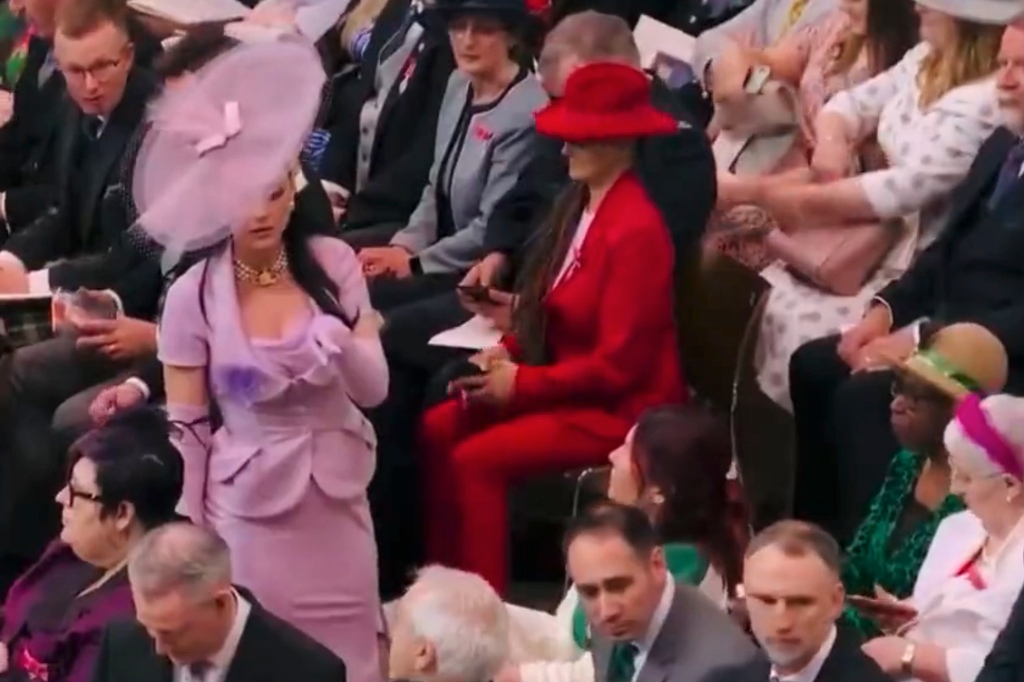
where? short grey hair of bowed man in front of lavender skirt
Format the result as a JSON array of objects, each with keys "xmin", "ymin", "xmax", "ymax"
[{"xmin": 128, "ymin": 523, "xmax": 231, "ymax": 596}]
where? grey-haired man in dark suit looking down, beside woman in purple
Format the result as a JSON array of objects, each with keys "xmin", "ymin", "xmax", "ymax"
[{"xmin": 92, "ymin": 523, "xmax": 345, "ymax": 682}]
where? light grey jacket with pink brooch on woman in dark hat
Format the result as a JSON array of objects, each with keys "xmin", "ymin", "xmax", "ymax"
[{"xmin": 391, "ymin": 71, "xmax": 548, "ymax": 273}]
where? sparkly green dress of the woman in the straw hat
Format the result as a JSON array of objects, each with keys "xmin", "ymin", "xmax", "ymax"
[{"xmin": 843, "ymin": 450, "xmax": 964, "ymax": 638}]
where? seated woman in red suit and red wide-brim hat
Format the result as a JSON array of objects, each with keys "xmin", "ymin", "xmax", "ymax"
[{"xmin": 422, "ymin": 63, "xmax": 687, "ymax": 591}]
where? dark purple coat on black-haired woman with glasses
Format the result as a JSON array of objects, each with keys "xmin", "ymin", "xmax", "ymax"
[{"xmin": 0, "ymin": 541, "xmax": 135, "ymax": 682}]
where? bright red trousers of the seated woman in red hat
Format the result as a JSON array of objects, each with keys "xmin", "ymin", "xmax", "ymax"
[{"xmin": 422, "ymin": 400, "xmax": 632, "ymax": 594}]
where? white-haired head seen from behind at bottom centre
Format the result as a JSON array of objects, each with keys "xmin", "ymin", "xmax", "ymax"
[{"xmin": 389, "ymin": 566, "xmax": 509, "ymax": 682}]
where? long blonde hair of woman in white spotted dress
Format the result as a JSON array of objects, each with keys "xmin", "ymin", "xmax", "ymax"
[{"xmin": 918, "ymin": 19, "xmax": 1004, "ymax": 109}]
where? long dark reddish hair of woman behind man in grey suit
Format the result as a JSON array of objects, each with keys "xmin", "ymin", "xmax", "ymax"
[{"xmin": 632, "ymin": 404, "xmax": 745, "ymax": 595}]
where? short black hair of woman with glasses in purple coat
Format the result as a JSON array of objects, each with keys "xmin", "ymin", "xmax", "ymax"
[{"xmin": 68, "ymin": 404, "xmax": 184, "ymax": 530}]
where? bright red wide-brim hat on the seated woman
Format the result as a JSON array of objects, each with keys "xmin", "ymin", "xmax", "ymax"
[{"xmin": 535, "ymin": 62, "xmax": 679, "ymax": 142}]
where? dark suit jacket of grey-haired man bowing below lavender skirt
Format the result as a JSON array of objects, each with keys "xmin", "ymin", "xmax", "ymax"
[{"xmin": 92, "ymin": 590, "xmax": 345, "ymax": 682}]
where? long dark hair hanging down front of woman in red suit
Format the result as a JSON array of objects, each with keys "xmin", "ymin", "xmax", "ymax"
[{"xmin": 512, "ymin": 182, "xmax": 588, "ymax": 365}]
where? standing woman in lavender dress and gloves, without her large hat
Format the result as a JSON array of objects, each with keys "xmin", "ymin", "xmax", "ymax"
[{"xmin": 159, "ymin": 164, "xmax": 387, "ymax": 682}]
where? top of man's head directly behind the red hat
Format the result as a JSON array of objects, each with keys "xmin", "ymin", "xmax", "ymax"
[{"xmin": 538, "ymin": 10, "xmax": 640, "ymax": 97}]
